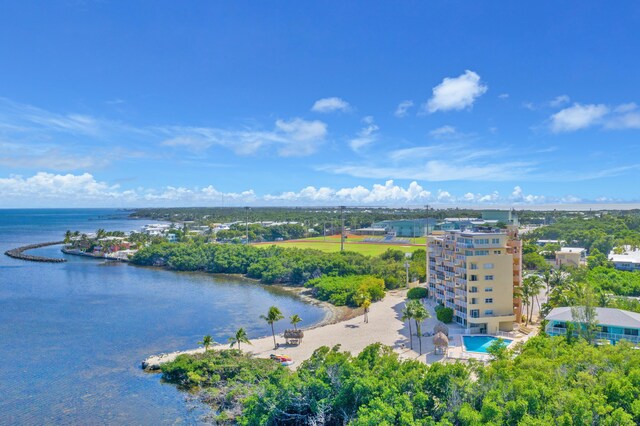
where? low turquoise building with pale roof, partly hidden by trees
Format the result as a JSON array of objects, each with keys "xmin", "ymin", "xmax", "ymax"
[{"xmin": 545, "ymin": 307, "xmax": 640, "ymax": 344}]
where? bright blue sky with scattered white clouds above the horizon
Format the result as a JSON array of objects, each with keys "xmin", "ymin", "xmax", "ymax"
[{"xmin": 0, "ymin": 1, "xmax": 640, "ymax": 207}]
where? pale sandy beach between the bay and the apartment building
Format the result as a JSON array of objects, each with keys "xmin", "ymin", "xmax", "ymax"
[{"xmin": 142, "ymin": 289, "xmax": 450, "ymax": 369}]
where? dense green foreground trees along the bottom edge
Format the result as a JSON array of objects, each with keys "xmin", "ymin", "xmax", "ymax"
[{"xmin": 162, "ymin": 336, "xmax": 640, "ymax": 426}]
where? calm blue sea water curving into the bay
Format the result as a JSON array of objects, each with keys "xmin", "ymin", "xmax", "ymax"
[{"xmin": 0, "ymin": 209, "xmax": 324, "ymax": 425}]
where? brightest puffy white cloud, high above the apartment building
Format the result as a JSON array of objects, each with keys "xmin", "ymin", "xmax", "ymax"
[{"xmin": 424, "ymin": 70, "xmax": 488, "ymax": 113}]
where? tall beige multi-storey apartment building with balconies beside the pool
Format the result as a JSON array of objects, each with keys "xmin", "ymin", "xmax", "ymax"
[{"xmin": 427, "ymin": 228, "xmax": 522, "ymax": 334}]
